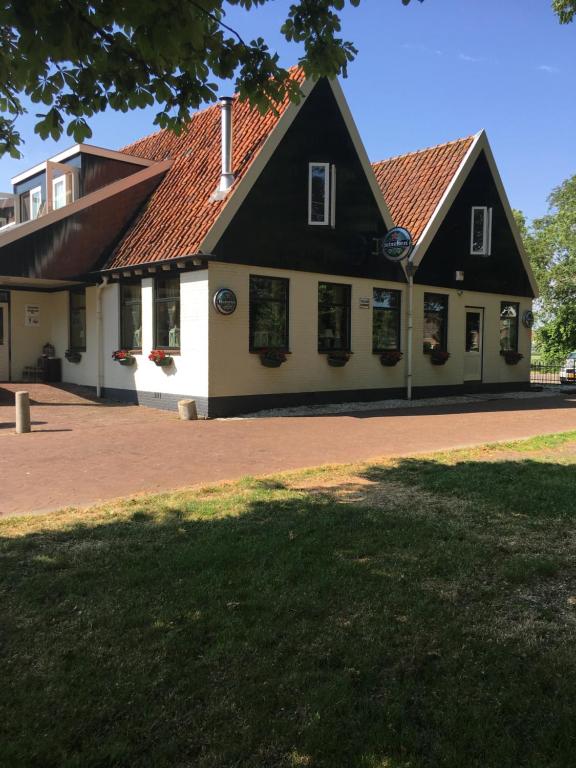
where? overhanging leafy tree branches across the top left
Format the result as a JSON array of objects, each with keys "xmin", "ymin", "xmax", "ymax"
[{"xmin": 0, "ymin": 0, "xmax": 376, "ymax": 157}]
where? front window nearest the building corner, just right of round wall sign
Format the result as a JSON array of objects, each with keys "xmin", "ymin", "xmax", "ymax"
[{"xmin": 249, "ymin": 275, "xmax": 288, "ymax": 352}]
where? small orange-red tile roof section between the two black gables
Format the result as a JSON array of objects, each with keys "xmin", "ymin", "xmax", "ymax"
[{"xmin": 372, "ymin": 136, "xmax": 475, "ymax": 242}]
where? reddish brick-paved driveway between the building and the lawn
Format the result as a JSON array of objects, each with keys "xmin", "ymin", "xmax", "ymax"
[{"xmin": 0, "ymin": 384, "xmax": 576, "ymax": 515}]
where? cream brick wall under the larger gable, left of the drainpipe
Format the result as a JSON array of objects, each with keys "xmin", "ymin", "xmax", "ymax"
[{"xmin": 209, "ymin": 263, "xmax": 406, "ymax": 397}]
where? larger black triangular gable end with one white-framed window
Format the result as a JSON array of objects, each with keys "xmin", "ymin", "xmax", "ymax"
[{"xmin": 212, "ymin": 80, "xmax": 405, "ymax": 282}]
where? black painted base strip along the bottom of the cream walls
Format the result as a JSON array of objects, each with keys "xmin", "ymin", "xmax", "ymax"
[{"xmin": 102, "ymin": 381, "xmax": 530, "ymax": 419}]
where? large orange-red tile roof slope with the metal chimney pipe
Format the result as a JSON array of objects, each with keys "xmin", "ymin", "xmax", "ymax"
[{"xmin": 106, "ymin": 68, "xmax": 304, "ymax": 269}]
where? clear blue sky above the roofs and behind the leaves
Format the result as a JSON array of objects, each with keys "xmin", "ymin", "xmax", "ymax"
[{"xmin": 0, "ymin": 0, "xmax": 576, "ymax": 219}]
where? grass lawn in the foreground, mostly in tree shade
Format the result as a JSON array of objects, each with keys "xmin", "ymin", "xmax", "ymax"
[{"xmin": 0, "ymin": 433, "xmax": 576, "ymax": 768}]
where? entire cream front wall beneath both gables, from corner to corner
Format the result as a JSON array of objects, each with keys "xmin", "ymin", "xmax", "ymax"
[{"xmin": 209, "ymin": 263, "xmax": 532, "ymax": 397}]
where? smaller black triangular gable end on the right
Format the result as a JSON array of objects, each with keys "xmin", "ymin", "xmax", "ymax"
[{"xmin": 415, "ymin": 152, "xmax": 534, "ymax": 297}]
